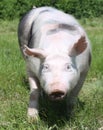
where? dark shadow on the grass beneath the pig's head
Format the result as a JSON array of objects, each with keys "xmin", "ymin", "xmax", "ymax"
[{"xmin": 39, "ymin": 94, "xmax": 84, "ymax": 130}]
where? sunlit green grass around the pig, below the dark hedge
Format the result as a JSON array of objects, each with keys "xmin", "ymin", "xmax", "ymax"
[{"xmin": 0, "ymin": 17, "xmax": 103, "ymax": 130}]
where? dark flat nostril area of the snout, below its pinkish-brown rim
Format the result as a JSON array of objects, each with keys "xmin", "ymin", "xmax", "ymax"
[{"xmin": 50, "ymin": 91, "xmax": 65, "ymax": 100}]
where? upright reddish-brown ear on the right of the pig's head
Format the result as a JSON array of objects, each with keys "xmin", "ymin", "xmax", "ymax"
[{"xmin": 69, "ymin": 36, "xmax": 87, "ymax": 56}]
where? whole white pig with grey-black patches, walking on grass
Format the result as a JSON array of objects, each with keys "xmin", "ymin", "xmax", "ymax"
[{"xmin": 18, "ymin": 7, "xmax": 91, "ymax": 120}]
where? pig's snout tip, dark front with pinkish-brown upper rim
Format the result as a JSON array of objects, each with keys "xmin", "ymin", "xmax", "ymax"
[{"xmin": 49, "ymin": 89, "xmax": 66, "ymax": 100}]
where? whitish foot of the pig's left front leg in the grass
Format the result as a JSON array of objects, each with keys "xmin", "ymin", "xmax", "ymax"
[{"xmin": 28, "ymin": 108, "xmax": 39, "ymax": 122}]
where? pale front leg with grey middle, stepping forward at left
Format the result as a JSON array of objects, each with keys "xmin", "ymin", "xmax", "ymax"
[{"xmin": 28, "ymin": 76, "xmax": 39, "ymax": 120}]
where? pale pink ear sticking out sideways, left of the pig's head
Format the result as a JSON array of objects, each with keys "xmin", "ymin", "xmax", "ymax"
[{"xmin": 23, "ymin": 45, "xmax": 47, "ymax": 59}]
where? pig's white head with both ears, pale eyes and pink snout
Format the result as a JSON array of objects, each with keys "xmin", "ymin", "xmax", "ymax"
[{"xmin": 25, "ymin": 37, "xmax": 87, "ymax": 100}]
